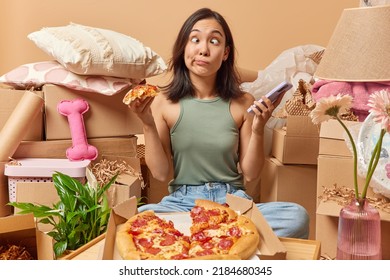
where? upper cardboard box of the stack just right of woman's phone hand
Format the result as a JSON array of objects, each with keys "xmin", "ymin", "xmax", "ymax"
[{"xmin": 271, "ymin": 116, "xmax": 319, "ymax": 165}]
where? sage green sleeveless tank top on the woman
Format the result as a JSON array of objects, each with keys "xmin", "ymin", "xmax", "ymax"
[{"xmin": 169, "ymin": 97, "xmax": 244, "ymax": 192}]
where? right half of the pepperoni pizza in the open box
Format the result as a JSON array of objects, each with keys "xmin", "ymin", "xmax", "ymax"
[{"xmin": 189, "ymin": 200, "xmax": 260, "ymax": 259}]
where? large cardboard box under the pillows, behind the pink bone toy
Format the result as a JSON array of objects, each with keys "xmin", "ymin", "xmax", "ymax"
[{"xmin": 43, "ymin": 84, "xmax": 142, "ymax": 140}]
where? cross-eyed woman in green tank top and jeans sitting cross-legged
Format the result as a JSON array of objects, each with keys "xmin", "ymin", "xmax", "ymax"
[{"xmin": 129, "ymin": 8, "xmax": 309, "ymax": 238}]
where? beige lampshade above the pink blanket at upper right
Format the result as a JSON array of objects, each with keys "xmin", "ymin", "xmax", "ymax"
[{"xmin": 314, "ymin": 5, "xmax": 390, "ymax": 82}]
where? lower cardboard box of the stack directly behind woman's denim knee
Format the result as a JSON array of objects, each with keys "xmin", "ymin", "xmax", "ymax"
[{"xmin": 260, "ymin": 157, "xmax": 317, "ymax": 239}]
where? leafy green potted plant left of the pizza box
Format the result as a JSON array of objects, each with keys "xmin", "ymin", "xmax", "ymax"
[{"xmin": 9, "ymin": 169, "xmax": 118, "ymax": 258}]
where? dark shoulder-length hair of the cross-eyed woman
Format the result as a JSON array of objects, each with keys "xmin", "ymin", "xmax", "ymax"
[{"xmin": 163, "ymin": 8, "xmax": 242, "ymax": 102}]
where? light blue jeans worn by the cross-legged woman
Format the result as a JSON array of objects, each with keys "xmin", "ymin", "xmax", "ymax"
[{"xmin": 138, "ymin": 183, "xmax": 309, "ymax": 239}]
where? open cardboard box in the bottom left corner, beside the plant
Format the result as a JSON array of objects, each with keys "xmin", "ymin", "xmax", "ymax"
[{"xmin": 0, "ymin": 214, "xmax": 39, "ymax": 260}]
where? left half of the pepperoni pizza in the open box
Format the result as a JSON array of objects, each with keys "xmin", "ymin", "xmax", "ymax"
[{"xmin": 116, "ymin": 210, "xmax": 190, "ymax": 260}]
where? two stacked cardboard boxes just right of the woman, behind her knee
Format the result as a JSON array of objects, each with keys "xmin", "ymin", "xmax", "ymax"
[{"xmin": 260, "ymin": 116, "xmax": 319, "ymax": 239}]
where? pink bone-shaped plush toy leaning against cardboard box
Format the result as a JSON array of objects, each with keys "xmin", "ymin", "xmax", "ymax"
[{"xmin": 57, "ymin": 99, "xmax": 98, "ymax": 161}]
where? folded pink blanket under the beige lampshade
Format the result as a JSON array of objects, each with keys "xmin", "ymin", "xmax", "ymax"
[{"xmin": 312, "ymin": 80, "xmax": 390, "ymax": 121}]
